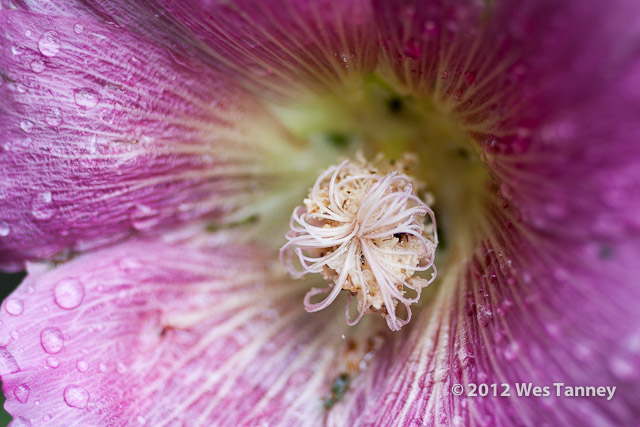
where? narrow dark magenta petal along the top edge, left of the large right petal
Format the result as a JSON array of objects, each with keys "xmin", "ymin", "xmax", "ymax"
[{"xmin": 15, "ymin": 0, "xmax": 376, "ymax": 96}]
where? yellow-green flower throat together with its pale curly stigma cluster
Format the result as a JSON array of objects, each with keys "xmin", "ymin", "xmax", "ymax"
[{"xmin": 239, "ymin": 72, "xmax": 497, "ymax": 330}]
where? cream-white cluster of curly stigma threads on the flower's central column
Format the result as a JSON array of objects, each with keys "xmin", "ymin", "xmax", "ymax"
[{"xmin": 280, "ymin": 154, "xmax": 438, "ymax": 331}]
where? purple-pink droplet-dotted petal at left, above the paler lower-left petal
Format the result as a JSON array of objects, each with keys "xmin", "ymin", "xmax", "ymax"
[{"xmin": 0, "ymin": 11, "xmax": 296, "ymax": 269}]
